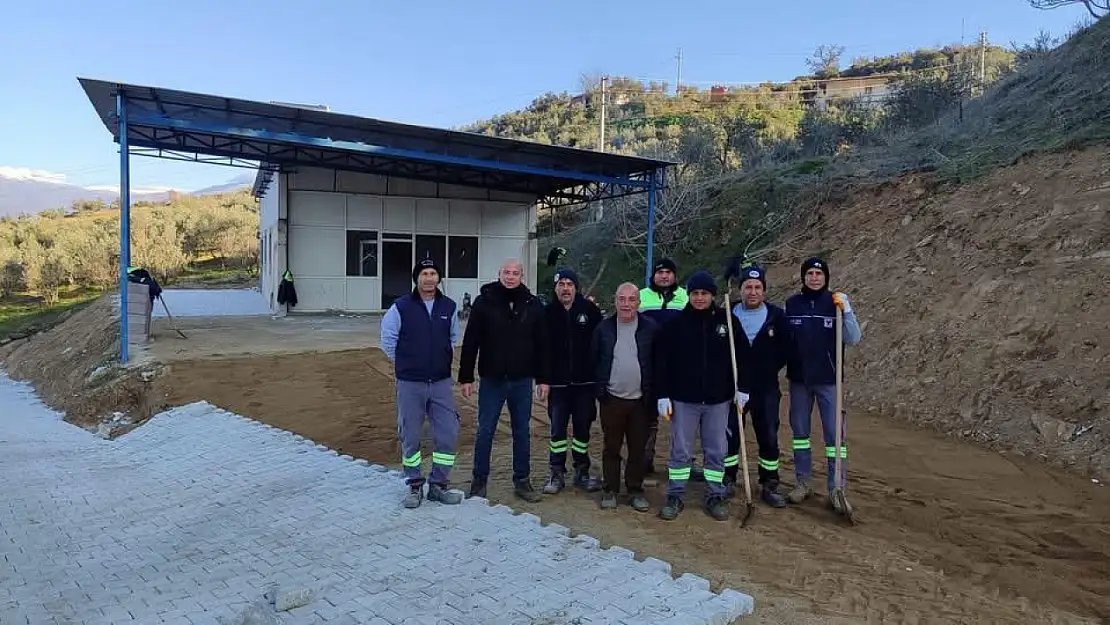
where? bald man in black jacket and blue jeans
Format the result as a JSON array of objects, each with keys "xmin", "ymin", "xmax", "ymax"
[{"xmin": 458, "ymin": 259, "xmax": 548, "ymax": 502}]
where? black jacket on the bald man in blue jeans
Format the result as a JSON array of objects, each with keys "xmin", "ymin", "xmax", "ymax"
[{"xmin": 458, "ymin": 282, "xmax": 549, "ymax": 384}]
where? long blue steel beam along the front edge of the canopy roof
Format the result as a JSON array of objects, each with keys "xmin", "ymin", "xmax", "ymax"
[{"xmin": 118, "ymin": 114, "xmax": 648, "ymax": 189}]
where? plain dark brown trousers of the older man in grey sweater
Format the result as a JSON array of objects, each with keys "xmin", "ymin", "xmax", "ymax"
[{"xmin": 601, "ymin": 394, "xmax": 655, "ymax": 494}]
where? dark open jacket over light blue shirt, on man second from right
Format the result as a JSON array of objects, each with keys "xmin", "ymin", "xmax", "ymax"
[{"xmin": 733, "ymin": 304, "xmax": 790, "ymax": 395}]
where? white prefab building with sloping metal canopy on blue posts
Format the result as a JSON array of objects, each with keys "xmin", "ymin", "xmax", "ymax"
[{"xmin": 78, "ymin": 78, "xmax": 673, "ymax": 355}]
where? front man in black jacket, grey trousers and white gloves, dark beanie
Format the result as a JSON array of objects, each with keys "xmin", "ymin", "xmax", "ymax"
[{"xmin": 655, "ymin": 271, "xmax": 748, "ymax": 521}]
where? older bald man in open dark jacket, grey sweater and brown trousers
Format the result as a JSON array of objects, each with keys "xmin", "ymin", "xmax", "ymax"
[{"xmin": 591, "ymin": 282, "xmax": 657, "ymax": 512}]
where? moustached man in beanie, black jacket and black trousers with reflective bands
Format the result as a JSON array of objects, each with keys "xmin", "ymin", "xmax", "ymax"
[{"xmin": 544, "ymin": 269, "xmax": 602, "ymax": 495}]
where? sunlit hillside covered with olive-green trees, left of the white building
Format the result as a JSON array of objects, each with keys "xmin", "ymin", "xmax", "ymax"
[{"xmin": 0, "ymin": 191, "xmax": 259, "ymax": 339}]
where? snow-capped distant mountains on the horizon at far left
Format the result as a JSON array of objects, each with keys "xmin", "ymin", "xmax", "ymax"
[{"xmin": 0, "ymin": 167, "xmax": 254, "ymax": 216}]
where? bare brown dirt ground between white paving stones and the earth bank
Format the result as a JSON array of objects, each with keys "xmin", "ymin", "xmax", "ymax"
[{"xmin": 157, "ymin": 350, "xmax": 1110, "ymax": 623}]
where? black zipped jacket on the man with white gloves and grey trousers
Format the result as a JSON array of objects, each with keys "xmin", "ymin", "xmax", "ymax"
[{"xmin": 655, "ymin": 304, "xmax": 747, "ymax": 404}]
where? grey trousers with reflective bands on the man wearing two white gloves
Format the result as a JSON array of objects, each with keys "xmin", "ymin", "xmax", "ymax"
[{"xmin": 667, "ymin": 402, "xmax": 731, "ymax": 497}]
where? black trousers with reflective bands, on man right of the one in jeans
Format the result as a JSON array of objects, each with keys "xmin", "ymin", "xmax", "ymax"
[{"xmin": 547, "ymin": 384, "xmax": 597, "ymax": 473}]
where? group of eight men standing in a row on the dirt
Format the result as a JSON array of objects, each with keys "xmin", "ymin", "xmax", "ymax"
[{"xmin": 381, "ymin": 251, "xmax": 861, "ymax": 521}]
